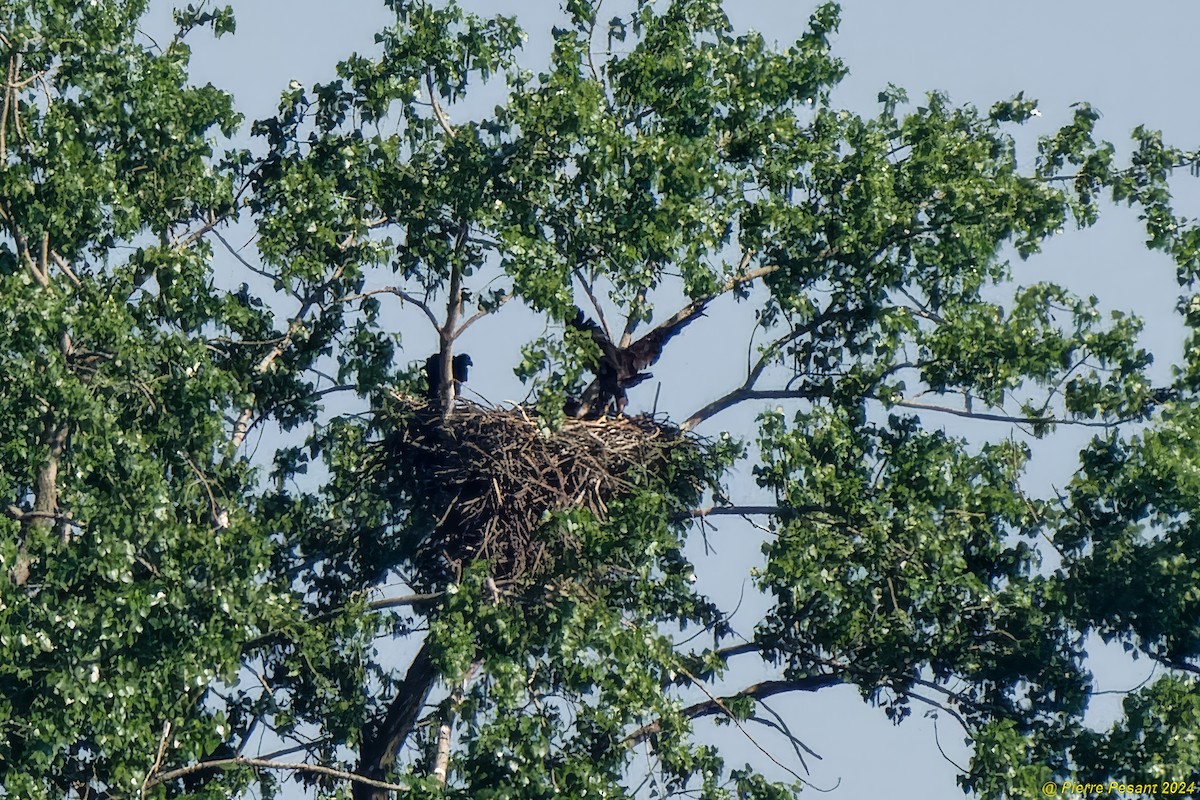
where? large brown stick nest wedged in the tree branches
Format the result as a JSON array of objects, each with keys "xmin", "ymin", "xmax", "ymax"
[{"xmin": 374, "ymin": 393, "xmax": 697, "ymax": 579}]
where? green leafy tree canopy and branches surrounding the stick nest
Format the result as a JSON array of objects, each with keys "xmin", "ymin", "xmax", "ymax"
[{"xmin": 0, "ymin": 0, "xmax": 1200, "ymax": 800}]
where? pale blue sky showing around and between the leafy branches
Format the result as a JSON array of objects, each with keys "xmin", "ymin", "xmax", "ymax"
[{"xmin": 164, "ymin": 0, "xmax": 1200, "ymax": 799}]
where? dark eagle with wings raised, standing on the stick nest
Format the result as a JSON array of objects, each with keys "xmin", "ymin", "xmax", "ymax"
[{"xmin": 564, "ymin": 303, "xmax": 704, "ymax": 419}]
